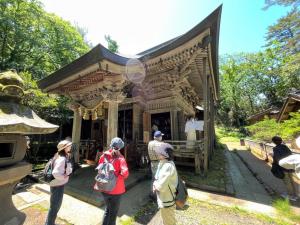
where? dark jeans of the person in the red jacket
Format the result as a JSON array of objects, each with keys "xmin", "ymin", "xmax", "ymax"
[{"xmin": 102, "ymin": 192, "xmax": 122, "ymax": 225}]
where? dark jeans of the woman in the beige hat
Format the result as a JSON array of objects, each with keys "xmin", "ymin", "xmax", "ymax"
[{"xmin": 45, "ymin": 185, "xmax": 65, "ymax": 225}]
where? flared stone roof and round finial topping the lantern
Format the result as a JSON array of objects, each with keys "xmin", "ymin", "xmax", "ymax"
[{"xmin": 0, "ymin": 71, "xmax": 58, "ymax": 134}]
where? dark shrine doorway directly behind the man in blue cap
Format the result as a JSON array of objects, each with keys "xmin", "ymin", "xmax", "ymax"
[{"xmin": 151, "ymin": 112, "xmax": 172, "ymax": 140}]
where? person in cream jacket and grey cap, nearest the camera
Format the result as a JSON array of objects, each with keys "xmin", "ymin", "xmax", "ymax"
[{"xmin": 153, "ymin": 143, "xmax": 178, "ymax": 225}]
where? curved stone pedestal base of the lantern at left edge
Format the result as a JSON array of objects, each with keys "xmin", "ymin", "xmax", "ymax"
[{"xmin": 0, "ymin": 162, "xmax": 31, "ymax": 225}]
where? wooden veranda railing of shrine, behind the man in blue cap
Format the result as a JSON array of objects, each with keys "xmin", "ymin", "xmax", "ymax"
[{"xmin": 137, "ymin": 140, "xmax": 204, "ymax": 174}]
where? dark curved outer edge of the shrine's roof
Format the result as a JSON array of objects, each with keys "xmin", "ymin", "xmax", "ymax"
[{"xmin": 38, "ymin": 5, "xmax": 222, "ymax": 93}]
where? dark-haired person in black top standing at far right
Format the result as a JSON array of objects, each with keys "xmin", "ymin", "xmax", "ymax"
[{"xmin": 271, "ymin": 136, "xmax": 297, "ymax": 201}]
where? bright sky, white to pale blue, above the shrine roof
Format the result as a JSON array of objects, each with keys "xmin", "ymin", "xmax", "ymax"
[{"xmin": 42, "ymin": 0, "xmax": 288, "ymax": 55}]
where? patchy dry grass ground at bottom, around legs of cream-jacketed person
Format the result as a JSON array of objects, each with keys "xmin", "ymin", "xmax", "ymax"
[{"xmin": 126, "ymin": 197, "xmax": 296, "ymax": 225}]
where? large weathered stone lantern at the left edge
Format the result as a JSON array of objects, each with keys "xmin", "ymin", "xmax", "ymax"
[{"xmin": 0, "ymin": 71, "xmax": 58, "ymax": 225}]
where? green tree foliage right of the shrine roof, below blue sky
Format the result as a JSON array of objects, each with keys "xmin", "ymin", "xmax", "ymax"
[{"xmin": 218, "ymin": 47, "xmax": 300, "ymax": 127}]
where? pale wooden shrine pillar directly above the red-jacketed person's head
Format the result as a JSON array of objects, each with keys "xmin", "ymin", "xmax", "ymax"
[{"xmin": 106, "ymin": 101, "xmax": 119, "ymax": 146}]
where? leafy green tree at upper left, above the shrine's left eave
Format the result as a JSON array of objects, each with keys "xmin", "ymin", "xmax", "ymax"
[{"xmin": 0, "ymin": 0, "xmax": 89, "ymax": 79}]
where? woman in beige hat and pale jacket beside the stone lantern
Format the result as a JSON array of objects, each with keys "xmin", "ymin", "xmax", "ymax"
[{"xmin": 45, "ymin": 140, "xmax": 72, "ymax": 225}]
